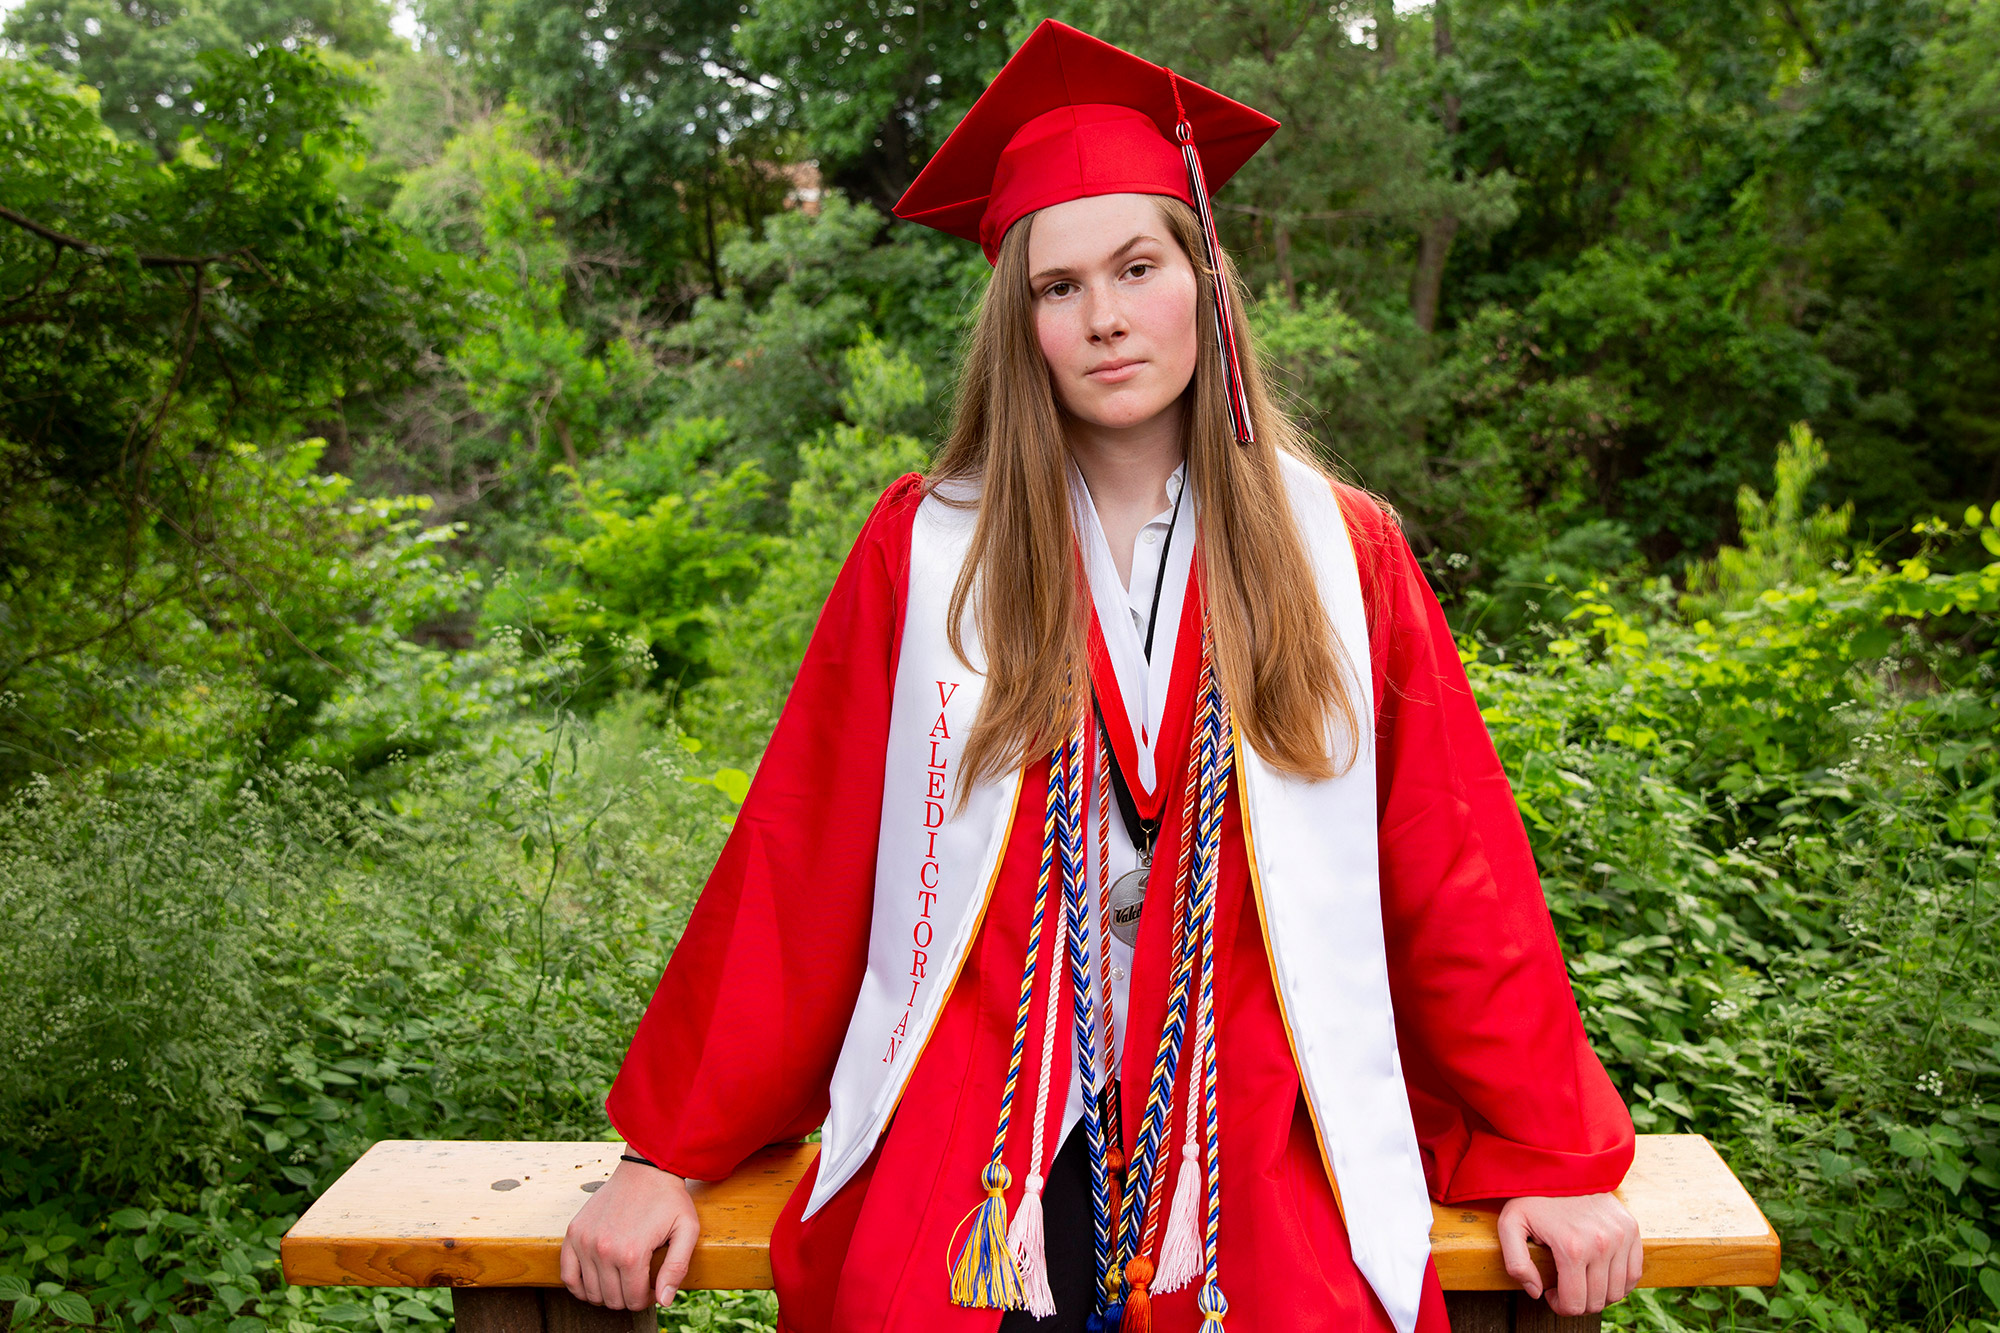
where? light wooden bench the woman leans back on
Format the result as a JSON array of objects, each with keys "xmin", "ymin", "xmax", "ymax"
[{"xmin": 282, "ymin": 1135, "xmax": 1778, "ymax": 1333}]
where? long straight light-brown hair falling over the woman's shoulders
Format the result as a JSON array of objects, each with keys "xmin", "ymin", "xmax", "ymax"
[{"xmin": 926, "ymin": 196, "xmax": 1358, "ymax": 793}]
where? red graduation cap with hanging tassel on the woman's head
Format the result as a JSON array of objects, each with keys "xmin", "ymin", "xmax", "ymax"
[{"xmin": 896, "ymin": 18, "xmax": 1278, "ymax": 442}]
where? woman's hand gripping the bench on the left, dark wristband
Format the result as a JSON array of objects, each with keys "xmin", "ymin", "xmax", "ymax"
[{"xmin": 562, "ymin": 1161, "xmax": 702, "ymax": 1309}]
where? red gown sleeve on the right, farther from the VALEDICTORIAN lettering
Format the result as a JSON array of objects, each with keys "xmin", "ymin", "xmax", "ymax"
[{"xmin": 1342, "ymin": 488, "xmax": 1632, "ymax": 1203}]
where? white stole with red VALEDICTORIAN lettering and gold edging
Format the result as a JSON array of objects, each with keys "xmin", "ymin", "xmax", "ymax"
[{"xmin": 806, "ymin": 456, "xmax": 1430, "ymax": 1333}]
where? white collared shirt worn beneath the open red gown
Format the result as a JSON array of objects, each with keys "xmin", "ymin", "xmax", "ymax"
[{"xmin": 1048, "ymin": 462, "xmax": 1196, "ymax": 1136}]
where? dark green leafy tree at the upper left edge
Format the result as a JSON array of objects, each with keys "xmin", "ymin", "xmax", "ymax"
[{"xmin": 0, "ymin": 50, "xmax": 462, "ymax": 775}]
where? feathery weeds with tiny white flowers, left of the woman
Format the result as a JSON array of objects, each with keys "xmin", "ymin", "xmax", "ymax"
[{"xmin": 0, "ymin": 684, "xmax": 744, "ymax": 1333}]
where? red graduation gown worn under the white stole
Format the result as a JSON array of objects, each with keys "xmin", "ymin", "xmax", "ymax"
[{"xmin": 608, "ymin": 476, "xmax": 1632, "ymax": 1333}]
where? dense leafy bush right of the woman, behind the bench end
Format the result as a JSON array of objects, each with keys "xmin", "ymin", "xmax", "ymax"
[{"xmin": 1472, "ymin": 472, "xmax": 2000, "ymax": 1333}]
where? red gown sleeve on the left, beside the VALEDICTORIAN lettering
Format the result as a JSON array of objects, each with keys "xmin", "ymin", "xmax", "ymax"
[{"xmin": 606, "ymin": 476, "xmax": 922, "ymax": 1181}]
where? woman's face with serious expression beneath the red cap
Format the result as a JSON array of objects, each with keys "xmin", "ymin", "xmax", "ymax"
[{"xmin": 1028, "ymin": 194, "xmax": 1198, "ymax": 430}]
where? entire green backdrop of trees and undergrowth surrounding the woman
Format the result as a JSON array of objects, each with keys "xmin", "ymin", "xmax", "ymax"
[{"xmin": 0, "ymin": 0, "xmax": 2000, "ymax": 1333}]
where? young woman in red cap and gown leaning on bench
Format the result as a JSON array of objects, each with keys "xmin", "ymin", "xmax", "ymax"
[{"xmin": 562, "ymin": 22, "xmax": 1642, "ymax": 1333}]
